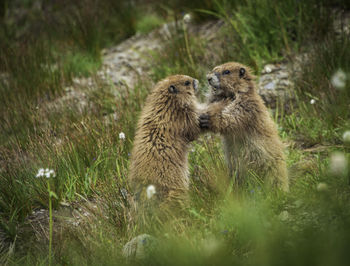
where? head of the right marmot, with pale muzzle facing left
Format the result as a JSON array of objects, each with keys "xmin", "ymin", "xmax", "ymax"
[{"xmin": 207, "ymin": 62, "xmax": 255, "ymax": 99}]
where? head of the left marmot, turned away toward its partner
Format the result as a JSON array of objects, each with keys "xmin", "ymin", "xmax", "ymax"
[{"xmin": 153, "ymin": 75, "xmax": 198, "ymax": 109}]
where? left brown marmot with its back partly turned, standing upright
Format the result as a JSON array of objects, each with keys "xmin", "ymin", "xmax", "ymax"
[{"xmin": 129, "ymin": 75, "xmax": 201, "ymax": 227}]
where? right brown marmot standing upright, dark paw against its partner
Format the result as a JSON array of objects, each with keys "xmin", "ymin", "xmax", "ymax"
[{"xmin": 200, "ymin": 62, "xmax": 289, "ymax": 191}]
